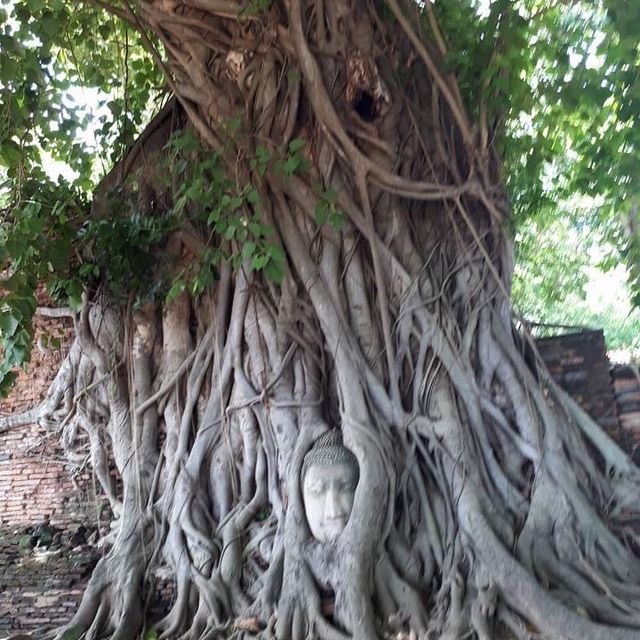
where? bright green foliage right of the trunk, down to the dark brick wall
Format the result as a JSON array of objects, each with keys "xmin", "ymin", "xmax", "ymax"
[{"xmin": 425, "ymin": 0, "xmax": 640, "ymax": 345}]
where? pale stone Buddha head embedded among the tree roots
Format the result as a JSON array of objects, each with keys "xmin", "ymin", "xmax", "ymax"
[{"xmin": 301, "ymin": 429, "xmax": 360, "ymax": 542}]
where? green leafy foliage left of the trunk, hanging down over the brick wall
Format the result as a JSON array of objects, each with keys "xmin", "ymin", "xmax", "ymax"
[{"xmin": 0, "ymin": 0, "xmax": 168, "ymax": 394}]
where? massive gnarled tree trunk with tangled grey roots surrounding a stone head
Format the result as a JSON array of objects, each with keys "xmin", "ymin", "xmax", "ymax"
[{"xmin": 5, "ymin": 0, "xmax": 640, "ymax": 640}]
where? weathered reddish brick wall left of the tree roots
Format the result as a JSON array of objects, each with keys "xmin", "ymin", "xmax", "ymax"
[{"xmin": 0, "ymin": 304, "xmax": 105, "ymax": 638}]
